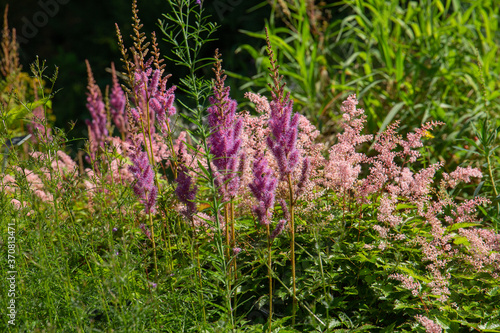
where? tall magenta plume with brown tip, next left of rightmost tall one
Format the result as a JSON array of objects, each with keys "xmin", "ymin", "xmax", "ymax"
[{"xmin": 207, "ymin": 51, "xmax": 244, "ymax": 199}]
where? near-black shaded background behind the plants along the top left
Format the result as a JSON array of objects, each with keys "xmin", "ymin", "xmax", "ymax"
[{"xmin": 0, "ymin": 0, "xmax": 270, "ymax": 147}]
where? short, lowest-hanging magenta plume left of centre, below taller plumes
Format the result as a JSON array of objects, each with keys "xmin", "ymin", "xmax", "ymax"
[{"xmin": 129, "ymin": 145, "xmax": 158, "ymax": 214}]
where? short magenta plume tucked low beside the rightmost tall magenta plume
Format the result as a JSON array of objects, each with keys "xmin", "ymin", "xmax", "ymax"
[{"xmin": 248, "ymin": 155, "xmax": 277, "ymax": 225}]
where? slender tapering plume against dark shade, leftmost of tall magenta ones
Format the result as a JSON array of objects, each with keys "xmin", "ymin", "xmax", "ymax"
[{"xmin": 85, "ymin": 60, "xmax": 108, "ymax": 160}]
